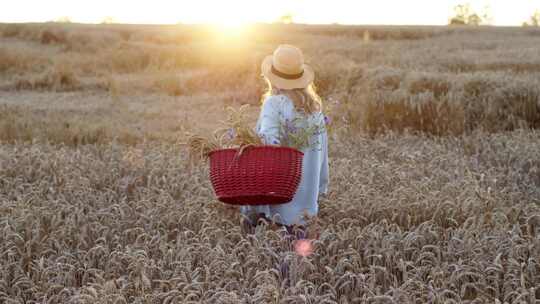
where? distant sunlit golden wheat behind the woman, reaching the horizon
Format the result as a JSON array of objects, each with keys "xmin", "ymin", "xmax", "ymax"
[{"xmin": 0, "ymin": 24, "xmax": 540, "ymax": 135}]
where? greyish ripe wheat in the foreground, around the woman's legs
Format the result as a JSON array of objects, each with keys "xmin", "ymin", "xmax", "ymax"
[{"xmin": 0, "ymin": 131, "xmax": 540, "ymax": 303}]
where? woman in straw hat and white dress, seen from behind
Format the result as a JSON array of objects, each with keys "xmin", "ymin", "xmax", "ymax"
[{"xmin": 241, "ymin": 45, "xmax": 328, "ymax": 238}]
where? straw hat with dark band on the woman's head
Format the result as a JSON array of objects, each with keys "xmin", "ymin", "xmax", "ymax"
[{"xmin": 261, "ymin": 44, "xmax": 315, "ymax": 90}]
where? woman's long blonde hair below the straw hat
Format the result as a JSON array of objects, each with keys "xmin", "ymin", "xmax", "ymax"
[{"xmin": 261, "ymin": 77, "xmax": 322, "ymax": 114}]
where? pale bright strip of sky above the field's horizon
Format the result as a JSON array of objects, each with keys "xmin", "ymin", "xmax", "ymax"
[{"xmin": 0, "ymin": 0, "xmax": 540, "ymax": 25}]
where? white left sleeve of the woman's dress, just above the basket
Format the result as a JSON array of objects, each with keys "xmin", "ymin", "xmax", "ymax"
[{"xmin": 257, "ymin": 96, "xmax": 282, "ymax": 145}]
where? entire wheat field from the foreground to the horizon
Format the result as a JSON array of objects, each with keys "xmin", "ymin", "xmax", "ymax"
[{"xmin": 0, "ymin": 23, "xmax": 540, "ymax": 304}]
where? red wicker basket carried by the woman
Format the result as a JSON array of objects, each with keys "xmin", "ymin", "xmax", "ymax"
[{"xmin": 209, "ymin": 146, "xmax": 304, "ymax": 205}]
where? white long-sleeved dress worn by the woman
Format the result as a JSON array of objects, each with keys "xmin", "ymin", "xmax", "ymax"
[{"xmin": 240, "ymin": 95, "xmax": 328, "ymax": 225}]
